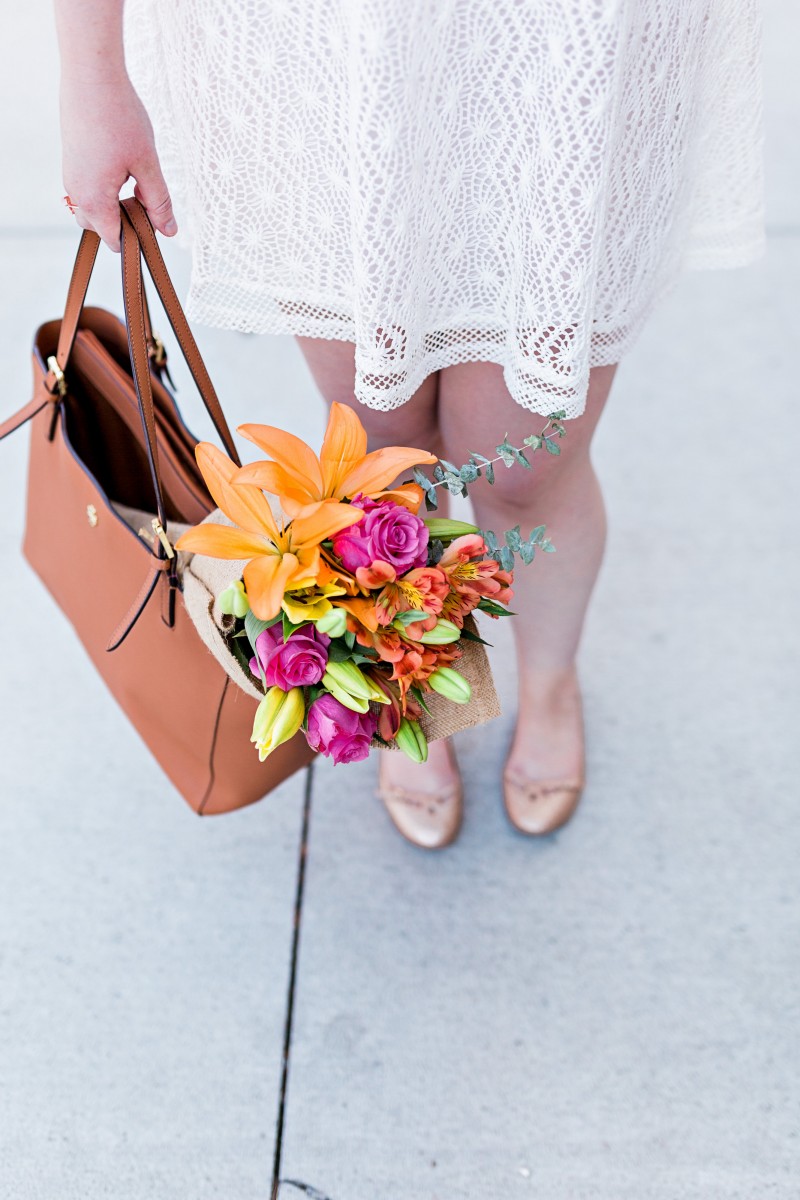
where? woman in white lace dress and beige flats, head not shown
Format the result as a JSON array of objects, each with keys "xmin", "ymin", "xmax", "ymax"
[{"xmin": 56, "ymin": 0, "xmax": 763, "ymax": 847}]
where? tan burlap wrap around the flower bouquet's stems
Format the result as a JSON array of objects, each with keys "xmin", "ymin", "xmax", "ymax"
[{"xmin": 172, "ymin": 511, "xmax": 500, "ymax": 742}]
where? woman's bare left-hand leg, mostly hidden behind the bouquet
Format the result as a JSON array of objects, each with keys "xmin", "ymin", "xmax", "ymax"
[{"xmin": 297, "ymin": 337, "xmax": 453, "ymax": 792}]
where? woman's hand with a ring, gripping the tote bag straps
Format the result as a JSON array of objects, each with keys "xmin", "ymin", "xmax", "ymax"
[{"xmin": 61, "ymin": 71, "xmax": 178, "ymax": 251}]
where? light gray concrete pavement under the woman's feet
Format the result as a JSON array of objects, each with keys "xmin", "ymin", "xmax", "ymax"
[{"xmin": 0, "ymin": 0, "xmax": 800, "ymax": 1200}]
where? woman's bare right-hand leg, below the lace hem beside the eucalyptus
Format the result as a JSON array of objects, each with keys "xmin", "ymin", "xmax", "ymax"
[{"xmin": 439, "ymin": 362, "xmax": 616, "ymax": 780}]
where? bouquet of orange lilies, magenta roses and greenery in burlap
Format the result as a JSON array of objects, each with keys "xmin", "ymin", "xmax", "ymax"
[{"xmin": 176, "ymin": 403, "xmax": 563, "ymax": 763}]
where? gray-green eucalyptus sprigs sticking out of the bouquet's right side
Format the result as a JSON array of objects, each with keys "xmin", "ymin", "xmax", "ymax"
[{"xmin": 414, "ymin": 409, "xmax": 566, "ymax": 571}]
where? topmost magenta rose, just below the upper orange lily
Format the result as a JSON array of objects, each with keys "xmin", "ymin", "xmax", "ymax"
[{"xmin": 333, "ymin": 496, "xmax": 428, "ymax": 575}]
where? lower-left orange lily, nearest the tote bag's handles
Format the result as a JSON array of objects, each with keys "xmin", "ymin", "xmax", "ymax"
[{"xmin": 175, "ymin": 442, "xmax": 363, "ymax": 620}]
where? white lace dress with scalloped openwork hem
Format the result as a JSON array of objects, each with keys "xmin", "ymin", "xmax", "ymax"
[{"xmin": 126, "ymin": 0, "xmax": 763, "ymax": 416}]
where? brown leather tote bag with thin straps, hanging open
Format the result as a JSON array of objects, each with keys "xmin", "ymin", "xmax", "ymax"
[{"xmin": 0, "ymin": 198, "xmax": 313, "ymax": 815}]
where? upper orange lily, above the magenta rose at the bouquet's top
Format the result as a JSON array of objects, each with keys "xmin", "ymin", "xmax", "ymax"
[{"xmin": 236, "ymin": 403, "xmax": 437, "ymax": 516}]
